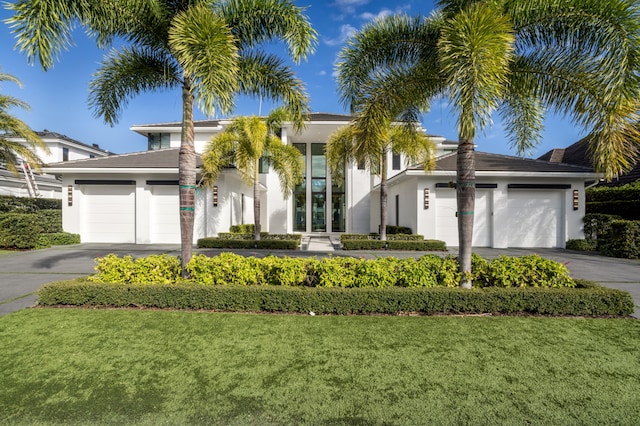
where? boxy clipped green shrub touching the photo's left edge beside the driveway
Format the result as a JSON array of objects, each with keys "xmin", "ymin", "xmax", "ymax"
[{"xmin": 0, "ymin": 213, "xmax": 43, "ymax": 250}]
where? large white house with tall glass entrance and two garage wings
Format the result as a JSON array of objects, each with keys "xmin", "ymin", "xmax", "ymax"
[{"xmin": 46, "ymin": 113, "xmax": 597, "ymax": 247}]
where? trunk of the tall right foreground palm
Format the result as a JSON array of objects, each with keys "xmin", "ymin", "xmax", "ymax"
[{"xmin": 456, "ymin": 138, "xmax": 476, "ymax": 288}]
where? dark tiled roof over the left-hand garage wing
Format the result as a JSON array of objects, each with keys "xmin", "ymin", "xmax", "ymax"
[{"xmin": 45, "ymin": 148, "xmax": 202, "ymax": 170}]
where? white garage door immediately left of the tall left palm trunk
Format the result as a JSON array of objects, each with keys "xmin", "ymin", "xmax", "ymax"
[{"xmin": 149, "ymin": 185, "xmax": 180, "ymax": 244}]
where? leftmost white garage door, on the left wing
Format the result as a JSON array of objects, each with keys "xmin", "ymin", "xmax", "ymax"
[{"xmin": 82, "ymin": 185, "xmax": 136, "ymax": 243}]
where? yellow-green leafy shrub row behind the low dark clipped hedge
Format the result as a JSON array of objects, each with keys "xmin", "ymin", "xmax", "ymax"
[{"xmin": 89, "ymin": 253, "xmax": 575, "ymax": 287}]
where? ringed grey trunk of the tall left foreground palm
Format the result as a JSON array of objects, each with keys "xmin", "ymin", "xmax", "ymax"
[{"xmin": 178, "ymin": 77, "xmax": 196, "ymax": 278}]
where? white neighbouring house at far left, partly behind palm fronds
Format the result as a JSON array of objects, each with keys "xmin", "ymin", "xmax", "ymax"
[{"xmin": 0, "ymin": 129, "xmax": 110, "ymax": 198}]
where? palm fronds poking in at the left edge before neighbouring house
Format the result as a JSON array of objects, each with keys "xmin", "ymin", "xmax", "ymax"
[{"xmin": 0, "ymin": 72, "xmax": 49, "ymax": 176}]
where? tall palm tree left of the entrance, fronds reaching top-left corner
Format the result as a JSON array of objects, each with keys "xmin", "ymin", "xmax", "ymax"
[{"xmin": 8, "ymin": 0, "xmax": 316, "ymax": 275}]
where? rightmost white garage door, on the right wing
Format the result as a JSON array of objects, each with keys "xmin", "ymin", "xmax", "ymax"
[{"xmin": 506, "ymin": 189, "xmax": 564, "ymax": 247}]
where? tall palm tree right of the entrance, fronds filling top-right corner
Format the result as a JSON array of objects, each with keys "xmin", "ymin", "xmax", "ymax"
[{"xmin": 338, "ymin": 0, "xmax": 640, "ymax": 287}]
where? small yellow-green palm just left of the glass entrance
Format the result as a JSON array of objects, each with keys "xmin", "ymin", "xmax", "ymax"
[{"xmin": 202, "ymin": 108, "xmax": 304, "ymax": 240}]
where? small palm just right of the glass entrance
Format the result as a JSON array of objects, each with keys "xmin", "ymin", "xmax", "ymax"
[{"xmin": 325, "ymin": 117, "xmax": 435, "ymax": 241}]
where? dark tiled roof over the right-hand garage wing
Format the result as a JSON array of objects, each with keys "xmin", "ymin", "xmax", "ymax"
[{"xmin": 420, "ymin": 152, "xmax": 593, "ymax": 173}]
